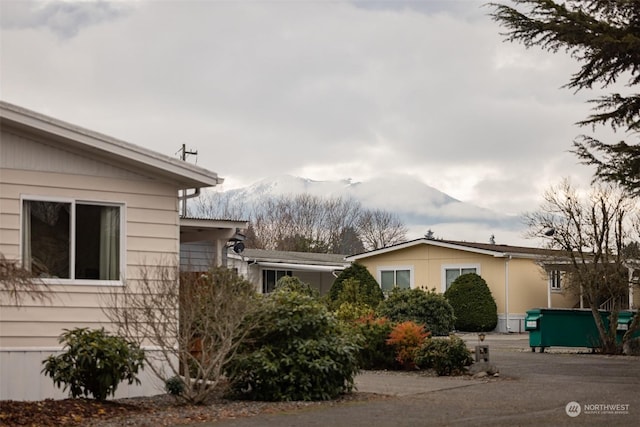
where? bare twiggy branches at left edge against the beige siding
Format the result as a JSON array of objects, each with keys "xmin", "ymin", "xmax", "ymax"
[{"xmin": 0, "ymin": 253, "xmax": 51, "ymax": 306}]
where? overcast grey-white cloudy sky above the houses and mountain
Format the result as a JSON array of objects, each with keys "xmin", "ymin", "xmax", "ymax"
[{"xmin": 0, "ymin": 0, "xmax": 594, "ymax": 219}]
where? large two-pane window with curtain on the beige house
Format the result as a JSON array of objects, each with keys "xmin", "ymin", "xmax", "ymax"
[{"xmin": 22, "ymin": 200, "xmax": 122, "ymax": 280}]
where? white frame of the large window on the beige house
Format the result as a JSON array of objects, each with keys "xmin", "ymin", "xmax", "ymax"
[{"xmin": 20, "ymin": 195, "xmax": 127, "ymax": 286}]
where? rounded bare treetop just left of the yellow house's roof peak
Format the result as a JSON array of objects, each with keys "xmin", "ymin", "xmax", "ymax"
[{"xmin": 358, "ymin": 209, "xmax": 407, "ymax": 250}]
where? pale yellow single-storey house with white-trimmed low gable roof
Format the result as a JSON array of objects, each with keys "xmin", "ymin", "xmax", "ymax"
[{"xmin": 346, "ymin": 238, "xmax": 580, "ymax": 332}]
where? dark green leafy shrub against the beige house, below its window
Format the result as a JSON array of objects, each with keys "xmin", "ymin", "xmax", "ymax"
[{"xmin": 42, "ymin": 328, "xmax": 144, "ymax": 400}]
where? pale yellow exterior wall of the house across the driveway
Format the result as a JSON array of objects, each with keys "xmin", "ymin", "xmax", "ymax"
[{"xmin": 358, "ymin": 245, "xmax": 577, "ymax": 332}]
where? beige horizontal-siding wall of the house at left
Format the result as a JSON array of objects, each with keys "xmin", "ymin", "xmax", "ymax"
[{"xmin": 0, "ymin": 129, "xmax": 179, "ymax": 399}]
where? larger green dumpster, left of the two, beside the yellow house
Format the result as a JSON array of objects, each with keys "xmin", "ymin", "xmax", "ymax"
[{"xmin": 525, "ymin": 308, "xmax": 609, "ymax": 353}]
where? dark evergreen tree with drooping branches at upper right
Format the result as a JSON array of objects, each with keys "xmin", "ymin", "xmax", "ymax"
[{"xmin": 490, "ymin": 0, "xmax": 640, "ymax": 196}]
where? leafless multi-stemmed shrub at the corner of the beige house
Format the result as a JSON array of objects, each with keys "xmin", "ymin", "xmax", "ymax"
[{"xmin": 103, "ymin": 263, "xmax": 259, "ymax": 403}]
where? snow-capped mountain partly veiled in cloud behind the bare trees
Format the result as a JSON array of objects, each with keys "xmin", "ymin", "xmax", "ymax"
[{"xmin": 215, "ymin": 174, "xmax": 534, "ymax": 246}]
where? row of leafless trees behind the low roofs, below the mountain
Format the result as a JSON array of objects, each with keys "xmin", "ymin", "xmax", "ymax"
[{"xmin": 191, "ymin": 193, "xmax": 407, "ymax": 253}]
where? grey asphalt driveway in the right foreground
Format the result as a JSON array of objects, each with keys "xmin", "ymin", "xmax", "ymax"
[{"xmin": 188, "ymin": 334, "xmax": 640, "ymax": 427}]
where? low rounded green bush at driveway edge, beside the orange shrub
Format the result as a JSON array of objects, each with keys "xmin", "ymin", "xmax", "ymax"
[{"xmin": 415, "ymin": 335, "xmax": 473, "ymax": 375}]
